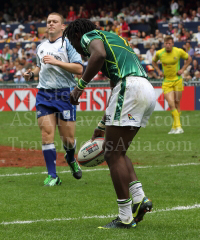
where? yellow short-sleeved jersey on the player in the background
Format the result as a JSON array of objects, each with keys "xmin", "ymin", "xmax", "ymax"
[{"xmin": 153, "ymin": 47, "xmax": 188, "ymax": 82}]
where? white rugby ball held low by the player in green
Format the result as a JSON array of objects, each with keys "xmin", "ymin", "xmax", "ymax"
[{"xmin": 78, "ymin": 137, "xmax": 104, "ymax": 167}]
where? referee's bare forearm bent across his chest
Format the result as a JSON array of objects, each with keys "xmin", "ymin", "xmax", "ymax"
[{"xmin": 43, "ymin": 55, "xmax": 83, "ymax": 75}]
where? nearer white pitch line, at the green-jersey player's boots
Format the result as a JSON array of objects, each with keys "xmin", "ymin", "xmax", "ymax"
[{"xmin": 0, "ymin": 204, "xmax": 200, "ymax": 225}]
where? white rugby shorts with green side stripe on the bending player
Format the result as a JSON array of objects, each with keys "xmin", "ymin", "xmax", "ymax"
[{"xmin": 105, "ymin": 76, "xmax": 156, "ymax": 127}]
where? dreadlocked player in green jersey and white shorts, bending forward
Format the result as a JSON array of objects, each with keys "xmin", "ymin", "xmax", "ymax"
[{"xmin": 63, "ymin": 19, "xmax": 156, "ymax": 228}]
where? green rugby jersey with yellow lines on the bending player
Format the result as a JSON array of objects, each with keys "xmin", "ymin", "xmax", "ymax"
[{"xmin": 81, "ymin": 30, "xmax": 147, "ymax": 84}]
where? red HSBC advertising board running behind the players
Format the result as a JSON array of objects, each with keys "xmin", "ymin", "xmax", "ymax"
[{"xmin": 0, "ymin": 87, "xmax": 195, "ymax": 111}]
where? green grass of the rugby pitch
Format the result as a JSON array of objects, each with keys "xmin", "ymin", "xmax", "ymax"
[{"xmin": 0, "ymin": 111, "xmax": 200, "ymax": 240}]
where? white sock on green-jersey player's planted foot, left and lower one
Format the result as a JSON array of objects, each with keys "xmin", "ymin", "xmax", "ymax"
[{"xmin": 117, "ymin": 198, "xmax": 133, "ymax": 223}]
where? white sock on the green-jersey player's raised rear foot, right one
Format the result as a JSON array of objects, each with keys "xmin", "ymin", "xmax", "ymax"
[{"xmin": 129, "ymin": 181, "xmax": 145, "ymax": 203}]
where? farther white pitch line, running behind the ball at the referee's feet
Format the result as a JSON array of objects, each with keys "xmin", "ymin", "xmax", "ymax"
[{"xmin": 0, "ymin": 163, "xmax": 200, "ymax": 177}]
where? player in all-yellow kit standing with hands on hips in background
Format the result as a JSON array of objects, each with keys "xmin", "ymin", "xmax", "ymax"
[{"xmin": 152, "ymin": 36, "xmax": 192, "ymax": 134}]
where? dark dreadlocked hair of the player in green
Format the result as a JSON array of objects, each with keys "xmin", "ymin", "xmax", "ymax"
[{"xmin": 62, "ymin": 18, "xmax": 96, "ymax": 44}]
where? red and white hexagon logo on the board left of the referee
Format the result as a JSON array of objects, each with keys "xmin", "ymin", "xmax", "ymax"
[{"xmin": 6, "ymin": 90, "xmax": 36, "ymax": 111}]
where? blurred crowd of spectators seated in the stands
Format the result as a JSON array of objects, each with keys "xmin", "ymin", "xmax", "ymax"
[{"xmin": 0, "ymin": 0, "xmax": 200, "ymax": 82}]
